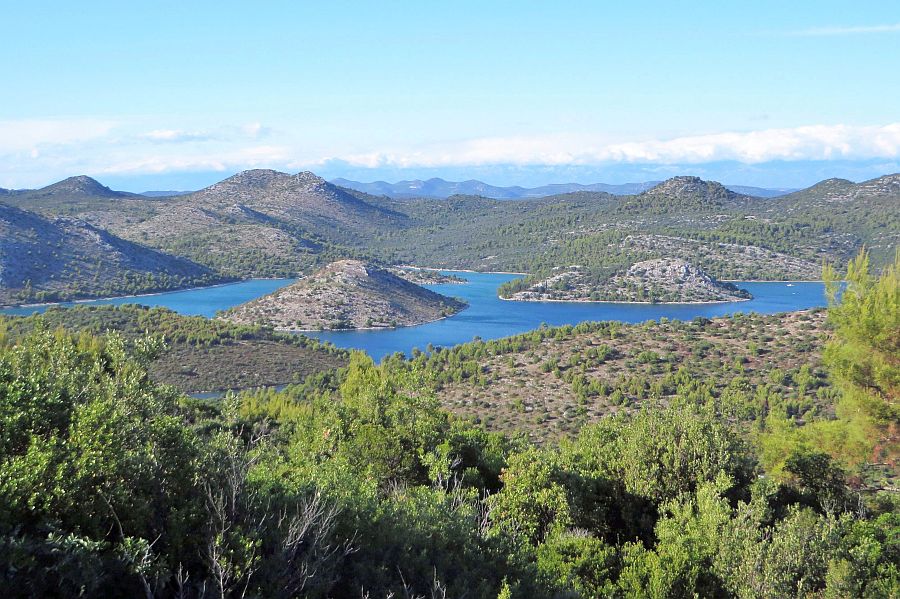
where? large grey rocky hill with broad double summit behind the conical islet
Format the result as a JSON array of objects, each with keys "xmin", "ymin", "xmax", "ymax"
[{"xmin": 88, "ymin": 169, "xmax": 406, "ymax": 277}]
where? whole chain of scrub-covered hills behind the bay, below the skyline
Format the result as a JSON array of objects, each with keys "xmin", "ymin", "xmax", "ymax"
[{"xmin": 3, "ymin": 170, "xmax": 900, "ymax": 308}]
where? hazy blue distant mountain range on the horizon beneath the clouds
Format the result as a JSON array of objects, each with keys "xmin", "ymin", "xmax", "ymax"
[{"xmin": 331, "ymin": 178, "xmax": 796, "ymax": 200}]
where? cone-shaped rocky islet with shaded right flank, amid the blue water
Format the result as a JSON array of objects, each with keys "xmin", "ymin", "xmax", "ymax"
[{"xmin": 223, "ymin": 260, "xmax": 465, "ymax": 331}]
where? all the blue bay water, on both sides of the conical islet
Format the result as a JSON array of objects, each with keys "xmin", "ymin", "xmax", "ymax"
[{"xmin": 0, "ymin": 271, "xmax": 825, "ymax": 360}]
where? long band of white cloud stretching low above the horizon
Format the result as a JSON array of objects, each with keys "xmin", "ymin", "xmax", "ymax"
[{"xmin": 0, "ymin": 119, "xmax": 900, "ymax": 187}]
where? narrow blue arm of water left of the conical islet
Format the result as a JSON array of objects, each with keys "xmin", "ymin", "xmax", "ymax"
[{"xmin": 0, "ymin": 279, "xmax": 296, "ymax": 318}]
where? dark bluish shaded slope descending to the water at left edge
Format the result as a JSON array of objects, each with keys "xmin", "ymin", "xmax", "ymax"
[{"xmin": 0, "ymin": 204, "xmax": 219, "ymax": 304}]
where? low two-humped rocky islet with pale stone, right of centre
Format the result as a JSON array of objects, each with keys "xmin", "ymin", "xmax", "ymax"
[{"xmin": 498, "ymin": 258, "xmax": 753, "ymax": 304}]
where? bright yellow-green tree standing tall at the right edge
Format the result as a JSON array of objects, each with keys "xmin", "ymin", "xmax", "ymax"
[{"xmin": 763, "ymin": 252, "xmax": 900, "ymax": 487}]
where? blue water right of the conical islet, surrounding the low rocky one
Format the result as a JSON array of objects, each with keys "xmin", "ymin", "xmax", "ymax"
[{"xmin": 308, "ymin": 271, "xmax": 825, "ymax": 360}]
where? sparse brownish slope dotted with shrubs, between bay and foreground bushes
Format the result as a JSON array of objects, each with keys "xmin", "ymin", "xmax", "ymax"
[{"xmin": 387, "ymin": 310, "xmax": 835, "ymax": 441}]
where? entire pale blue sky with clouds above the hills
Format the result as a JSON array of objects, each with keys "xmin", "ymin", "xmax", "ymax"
[{"xmin": 0, "ymin": 0, "xmax": 900, "ymax": 191}]
